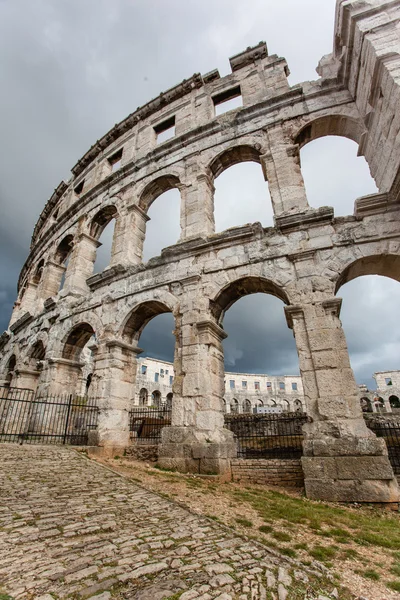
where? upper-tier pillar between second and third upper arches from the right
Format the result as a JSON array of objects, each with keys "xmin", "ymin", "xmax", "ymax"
[{"xmin": 180, "ymin": 173, "xmax": 215, "ymax": 242}]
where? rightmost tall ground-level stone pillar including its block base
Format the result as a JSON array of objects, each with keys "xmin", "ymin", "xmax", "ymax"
[{"xmin": 285, "ymin": 298, "xmax": 399, "ymax": 503}]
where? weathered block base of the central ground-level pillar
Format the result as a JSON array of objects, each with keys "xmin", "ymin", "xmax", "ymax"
[{"xmin": 158, "ymin": 427, "xmax": 237, "ymax": 475}]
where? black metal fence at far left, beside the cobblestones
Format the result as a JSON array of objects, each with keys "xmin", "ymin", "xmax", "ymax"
[{"xmin": 0, "ymin": 387, "xmax": 99, "ymax": 446}]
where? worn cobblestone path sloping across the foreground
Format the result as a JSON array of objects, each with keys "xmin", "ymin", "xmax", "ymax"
[{"xmin": 0, "ymin": 444, "xmax": 338, "ymax": 600}]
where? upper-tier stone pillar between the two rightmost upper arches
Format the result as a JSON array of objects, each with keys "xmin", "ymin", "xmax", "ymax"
[{"xmin": 260, "ymin": 125, "xmax": 310, "ymax": 217}]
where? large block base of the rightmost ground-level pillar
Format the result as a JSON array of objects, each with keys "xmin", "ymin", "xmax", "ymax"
[{"xmin": 301, "ymin": 437, "xmax": 400, "ymax": 504}]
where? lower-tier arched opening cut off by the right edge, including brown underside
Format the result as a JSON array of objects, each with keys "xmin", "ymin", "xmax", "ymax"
[{"xmin": 336, "ymin": 255, "xmax": 400, "ymax": 395}]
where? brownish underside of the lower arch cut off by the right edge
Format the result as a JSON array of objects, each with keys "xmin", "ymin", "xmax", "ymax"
[{"xmin": 335, "ymin": 254, "xmax": 400, "ymax": 294}]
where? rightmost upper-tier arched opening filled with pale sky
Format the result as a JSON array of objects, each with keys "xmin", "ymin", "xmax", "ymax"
[{"xmin": 300, "ymin": 134, "xmax": 379, "ymax": 217}]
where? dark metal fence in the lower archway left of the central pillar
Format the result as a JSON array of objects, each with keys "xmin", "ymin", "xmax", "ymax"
[{"xmin": 129, "ymin": 405, "xmax": 171, "ymax": 444}]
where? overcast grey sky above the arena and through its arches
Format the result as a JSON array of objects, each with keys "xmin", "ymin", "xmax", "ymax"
[{"xmin": 0, "ymin": 0, "xmax": 400, "ymax": 386}]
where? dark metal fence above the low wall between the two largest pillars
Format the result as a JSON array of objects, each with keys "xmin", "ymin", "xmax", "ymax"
[{"xmin": 225, "ymin": 413, "xmax": 309, "ymax": 459}]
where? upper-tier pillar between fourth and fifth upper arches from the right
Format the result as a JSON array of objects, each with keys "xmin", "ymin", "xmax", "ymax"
[{"xmin": 63, "ymin": 232, "xmax": 101, "ymax": 295}]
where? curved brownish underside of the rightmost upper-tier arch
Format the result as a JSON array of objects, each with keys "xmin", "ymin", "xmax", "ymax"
[{"xmin": 293, "ymin": 114, "xmax": 364, "ymax": 148}]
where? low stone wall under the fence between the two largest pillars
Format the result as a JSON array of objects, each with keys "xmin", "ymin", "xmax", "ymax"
[{"xmin": 231, "ymin": 458, "xmax": 304, "ymax": 488}]
